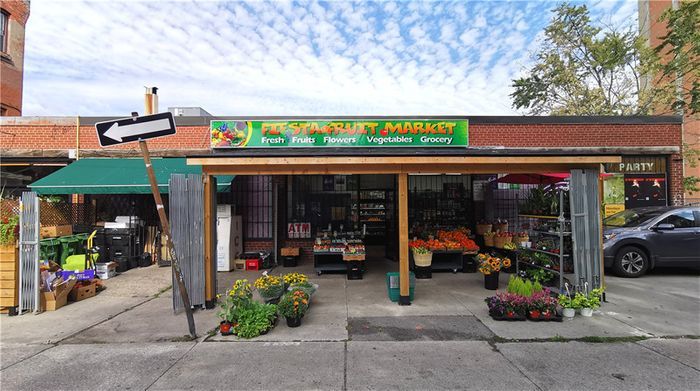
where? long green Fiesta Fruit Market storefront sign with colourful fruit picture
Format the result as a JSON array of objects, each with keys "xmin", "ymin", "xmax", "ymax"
[{"xmin": 210, "ymin": 119, "xmax": 469, "ymax": 148}]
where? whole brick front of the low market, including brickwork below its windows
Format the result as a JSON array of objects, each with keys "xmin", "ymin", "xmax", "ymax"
[{"xmin": 0, "ymin": 117, "xmax": 683, "ymax": 258}]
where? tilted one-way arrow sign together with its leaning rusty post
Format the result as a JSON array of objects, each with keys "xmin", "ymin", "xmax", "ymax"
[{"xmin": 95, "ymin": 113, "xmax": 197, "ymax": 338}]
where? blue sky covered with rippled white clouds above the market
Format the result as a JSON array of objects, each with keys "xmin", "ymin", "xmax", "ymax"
[{"xmin": 23, "ymin": 0, "xmax": 637, "ymax": 116}]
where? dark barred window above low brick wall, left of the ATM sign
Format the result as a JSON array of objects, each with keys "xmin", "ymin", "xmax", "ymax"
[{"xmin": 232, "ymin": 175, "xmax": 272, "ymax": 240}]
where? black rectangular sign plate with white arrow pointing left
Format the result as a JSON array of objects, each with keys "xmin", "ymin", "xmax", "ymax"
[{"xmin": 95, "ymin": 113, "xmax": 176, "ymax": 147}]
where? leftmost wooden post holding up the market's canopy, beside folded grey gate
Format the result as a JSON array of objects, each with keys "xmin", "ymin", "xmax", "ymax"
[{"xmin": 203, "ymin": 174, "xmax": 216, "ymax": 308}]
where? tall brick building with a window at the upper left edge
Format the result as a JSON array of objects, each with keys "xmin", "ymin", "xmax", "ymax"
[{"xmin": 0, "ymin": 0, "xmax": 29, "ymax": 116}]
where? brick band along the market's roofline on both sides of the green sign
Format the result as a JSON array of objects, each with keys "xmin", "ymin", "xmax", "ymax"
[{"xmin": 0, "ymin": 122, "xmax": 681, "ymax": 156}]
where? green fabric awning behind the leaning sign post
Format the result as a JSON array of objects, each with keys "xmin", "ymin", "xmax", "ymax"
[{"xmin": 29, "ymin": 158, "xmax": 233, "ymax": 194}]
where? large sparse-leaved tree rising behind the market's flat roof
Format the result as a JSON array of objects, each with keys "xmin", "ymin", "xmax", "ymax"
[{"xmin": 511, "ymin": 3, "xmax": 674, "ymax": 115}]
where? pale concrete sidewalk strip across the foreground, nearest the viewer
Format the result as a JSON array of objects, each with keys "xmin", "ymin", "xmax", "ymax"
[{"xmin": 0, "ymin": 339, "xmax": 700, "ymax": 391}]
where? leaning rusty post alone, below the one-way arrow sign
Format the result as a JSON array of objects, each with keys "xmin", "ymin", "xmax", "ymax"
[{"xmin": 139, "ymin": 140, "xmax": 197, "ymax": 339}]
